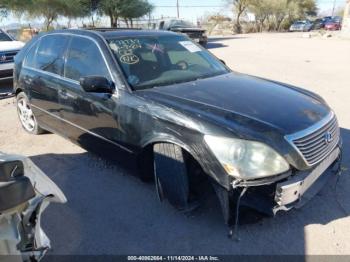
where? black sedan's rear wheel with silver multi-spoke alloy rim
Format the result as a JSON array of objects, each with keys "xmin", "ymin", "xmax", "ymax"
[{"xmin": 17, "ymin": 92, "xmax": 44, "ymax": 135}]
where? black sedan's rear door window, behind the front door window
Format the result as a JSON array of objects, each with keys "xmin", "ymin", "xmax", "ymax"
[{"xmin": 33, "ymin": 35, "xmax": 69, "ymax": 75}]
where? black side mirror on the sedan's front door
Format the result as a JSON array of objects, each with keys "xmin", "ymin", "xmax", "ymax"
[{"xmin": 79, "ymin": 76, "xmax": 113, "ymax": 94}]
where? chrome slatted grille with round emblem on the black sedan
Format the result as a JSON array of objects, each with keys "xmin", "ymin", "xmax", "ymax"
[{"xmin": 291, "ymin": 115, "xmax": 340, "ymax": 166}]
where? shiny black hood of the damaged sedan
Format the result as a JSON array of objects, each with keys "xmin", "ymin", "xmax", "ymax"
[{"xmin": 138, "ymin": 73, "xmax": 330, "ymax": 135}]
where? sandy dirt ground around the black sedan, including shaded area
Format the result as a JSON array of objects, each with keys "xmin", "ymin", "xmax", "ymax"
[{"xmin": 0, "ymin": 33, "xmax": 350, "ymax": 255}]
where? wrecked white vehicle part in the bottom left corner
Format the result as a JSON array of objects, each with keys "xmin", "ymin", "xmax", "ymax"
[{"xmin": 0, "ymin": 152, "xmax": 67, "ymax": 262}]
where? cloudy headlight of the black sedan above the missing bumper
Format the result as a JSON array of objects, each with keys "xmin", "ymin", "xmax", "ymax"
[{"xmin": 204, "ymin": 135, "xmax": 289, "ymax": 179}]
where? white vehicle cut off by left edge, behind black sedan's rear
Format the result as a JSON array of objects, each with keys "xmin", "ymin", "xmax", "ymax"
[{"xmin": 0, "ymin": 29, "xmax": 24, "ymax": 80}]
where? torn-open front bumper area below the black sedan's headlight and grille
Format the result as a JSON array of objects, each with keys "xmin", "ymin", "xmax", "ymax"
[{"xmin": 214, "ymin": 147, "xmax": 341, "ymax": 225}]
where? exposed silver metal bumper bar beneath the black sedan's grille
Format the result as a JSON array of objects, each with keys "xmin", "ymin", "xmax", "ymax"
[{"xmin": 273, "ymin": 147, "xmax": 341, "ymax": 214}]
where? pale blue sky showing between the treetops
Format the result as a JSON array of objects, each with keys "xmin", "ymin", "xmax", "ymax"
[{"xmin": 0, "ymin": 0, "xmax": 345, "ymax": 26}]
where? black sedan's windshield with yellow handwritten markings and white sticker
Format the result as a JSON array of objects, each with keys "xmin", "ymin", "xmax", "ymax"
[{"xmin": 108, "ymin": 35, "xmax": 229, "ymax": 90}]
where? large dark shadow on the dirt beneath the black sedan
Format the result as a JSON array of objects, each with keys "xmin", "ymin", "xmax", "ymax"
[{"xmin": 31, "ymin": 129, "xmax": 350, "ymax": 255}]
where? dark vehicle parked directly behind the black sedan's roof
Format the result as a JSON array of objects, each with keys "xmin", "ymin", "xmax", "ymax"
[{"xmin": 158, "ymin": 19, "xmax": 208, "ymax": 47}]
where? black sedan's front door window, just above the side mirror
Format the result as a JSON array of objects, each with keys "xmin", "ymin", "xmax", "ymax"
[{"xmin": 65, "ymin": 37, "xmax": 110, "ymax": 81}]
